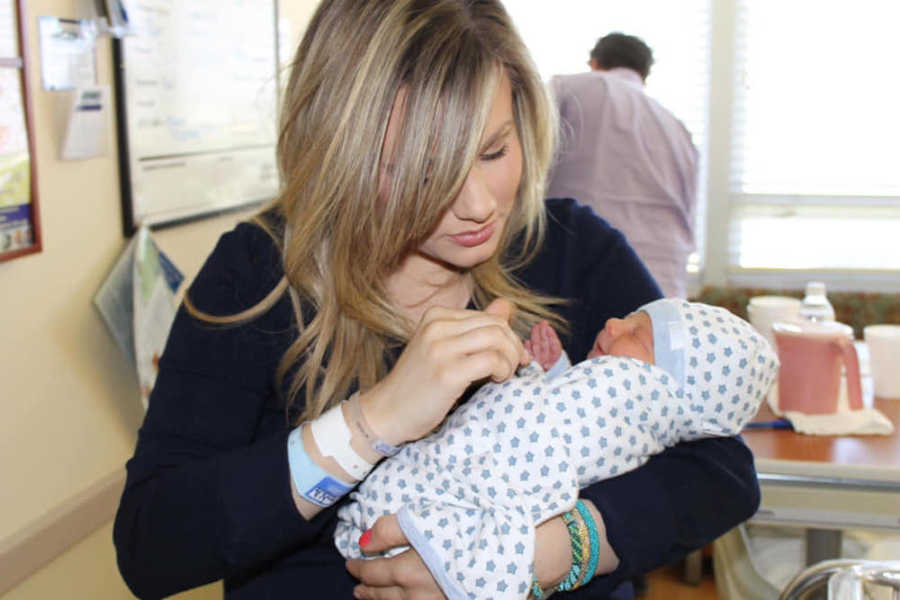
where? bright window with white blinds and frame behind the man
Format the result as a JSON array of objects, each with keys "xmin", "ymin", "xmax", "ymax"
[{"xmin": 505, "ymin": 0, "xmax": 900, "ymax": 291}]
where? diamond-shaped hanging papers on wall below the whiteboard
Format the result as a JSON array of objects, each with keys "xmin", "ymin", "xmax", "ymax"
[{"xmin": 94, "ymin": 227, "xmax": 184, "ymax": 410}]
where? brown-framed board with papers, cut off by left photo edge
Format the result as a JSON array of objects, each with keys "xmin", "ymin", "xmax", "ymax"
[{"xmin": 0, "ymin": 0, "xmax": 41, "ymax": 261}]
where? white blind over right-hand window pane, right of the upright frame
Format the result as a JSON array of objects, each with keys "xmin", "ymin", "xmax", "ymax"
[{"xmin": 729, "ymin": 0, "xmax": 900, "ymax": 287}]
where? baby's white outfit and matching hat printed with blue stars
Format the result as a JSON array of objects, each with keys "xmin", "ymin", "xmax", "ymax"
[{"xmin": 335, "ymin": 300, "xmax": 778, "ymax": 600}]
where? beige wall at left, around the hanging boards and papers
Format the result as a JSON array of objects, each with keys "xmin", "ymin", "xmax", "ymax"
[{"xmin": 0, "ymin": 0, "xmax": 316, "ymax": 600}]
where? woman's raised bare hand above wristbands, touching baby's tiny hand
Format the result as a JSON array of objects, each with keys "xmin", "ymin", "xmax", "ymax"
[{"xmin": 360, "ymin": 299, "xmax": 528, "ymax": 445}]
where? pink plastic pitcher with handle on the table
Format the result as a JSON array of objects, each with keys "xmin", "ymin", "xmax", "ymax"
[{"xmin": 772, "ymin": 321, "xmax": 863, "ymax": 414}]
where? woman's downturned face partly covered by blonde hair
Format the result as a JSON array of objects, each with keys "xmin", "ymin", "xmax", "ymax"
[{"xmin": 385, "ymin": 74, "xmax": 522, "ymax": 269}]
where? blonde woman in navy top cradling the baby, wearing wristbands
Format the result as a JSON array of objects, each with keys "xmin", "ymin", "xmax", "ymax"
[{"xmin": 115, "ymin": 0, "xmax": 759, "ymax": 599}]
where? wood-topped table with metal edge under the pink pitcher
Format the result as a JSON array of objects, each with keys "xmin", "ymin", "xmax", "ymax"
[{"xmin": 743, "ymin": 398, "xmax": 900, "ymax": 564}]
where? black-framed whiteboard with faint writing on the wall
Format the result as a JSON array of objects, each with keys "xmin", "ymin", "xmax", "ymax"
[{"xmin": 113, "ymin": 0, "xmax": 279, "ymax": 236}]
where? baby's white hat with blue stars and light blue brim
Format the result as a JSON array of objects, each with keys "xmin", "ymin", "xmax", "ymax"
[{"xmin": 639, "ymin": 298, "xmax": 778, "ymax": 434}]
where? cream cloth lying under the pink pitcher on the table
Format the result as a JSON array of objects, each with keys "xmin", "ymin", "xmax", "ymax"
[{"xmin": 767, "ymin": 382, "xmax": 894, "ymax": 435}]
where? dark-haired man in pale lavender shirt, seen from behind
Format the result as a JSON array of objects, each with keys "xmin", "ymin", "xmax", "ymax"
[{"xmin": 548, "ymin": 33, "xmax": 699, "ymax": 298}]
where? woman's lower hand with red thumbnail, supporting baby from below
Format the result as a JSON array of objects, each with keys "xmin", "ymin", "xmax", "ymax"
[{"xmin": 347, "ymin": 515, "xmax": 446, "ymax": 600}]
